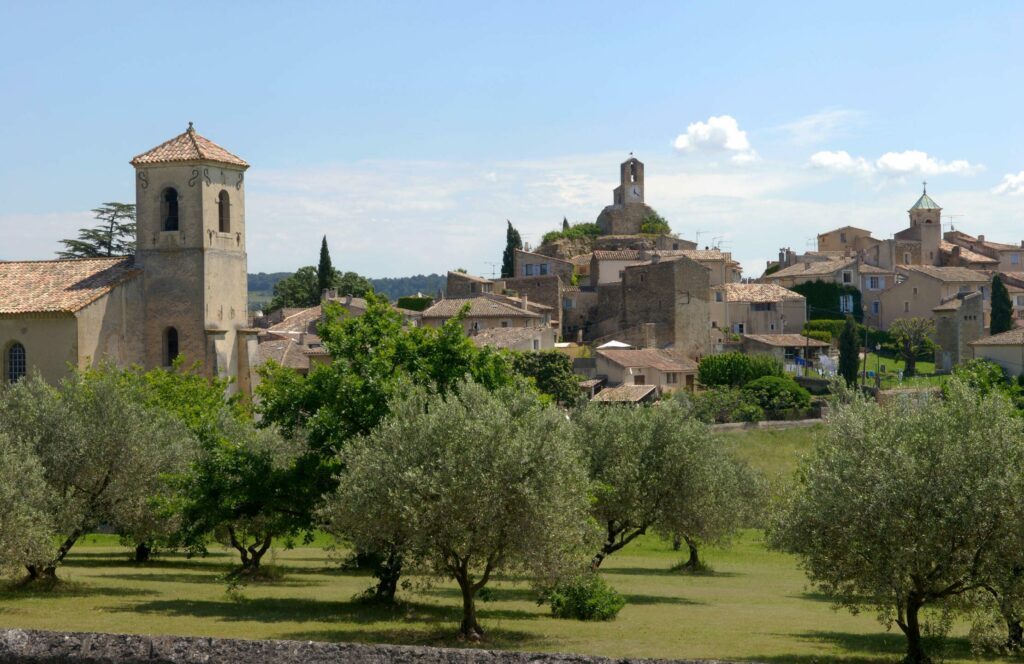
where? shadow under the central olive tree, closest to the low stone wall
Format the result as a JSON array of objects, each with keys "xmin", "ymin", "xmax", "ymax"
[{"xmin": 280, "ymin": 627, "xmax": 551, "ymax": 650}]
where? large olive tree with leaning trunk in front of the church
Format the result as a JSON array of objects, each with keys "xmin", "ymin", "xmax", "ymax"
[{"xmin": 0, "ymin": 368, "xmax": 193, "ymax": 579}]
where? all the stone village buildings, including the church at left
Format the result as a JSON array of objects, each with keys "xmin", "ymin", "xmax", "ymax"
[{"xmin": 0, "ymin": 126, "xmax": 1024, "ymax": 401}]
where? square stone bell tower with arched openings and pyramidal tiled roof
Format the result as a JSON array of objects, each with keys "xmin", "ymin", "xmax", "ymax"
[{"xmin": 131, "ymin": 122, "xmax": 249, "ymax": 387}]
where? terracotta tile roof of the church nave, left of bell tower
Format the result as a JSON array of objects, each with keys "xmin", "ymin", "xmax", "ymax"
[{"xmin": 0, "ymin": 257, "xmax": 142, "ymax": 314}]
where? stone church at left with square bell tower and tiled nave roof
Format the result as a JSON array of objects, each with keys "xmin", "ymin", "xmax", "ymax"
[{"xmin": 0, "ymin": 123, "xmax": 256, "ymax": 392}]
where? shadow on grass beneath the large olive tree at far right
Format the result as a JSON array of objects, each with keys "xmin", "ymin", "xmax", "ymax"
[{"xmin": 750, "ymin": 631, "xmax": 975, "ymax": 664}]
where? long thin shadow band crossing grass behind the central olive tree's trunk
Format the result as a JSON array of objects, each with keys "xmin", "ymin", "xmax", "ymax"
[{"xmin": 113, "ymin": 597, "xmax": 542, "ymax": 624}]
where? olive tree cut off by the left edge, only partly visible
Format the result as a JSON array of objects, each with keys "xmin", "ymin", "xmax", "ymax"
[{"xmin": 0, "ymin": 432, "xmax": 52, "ymax": 573}]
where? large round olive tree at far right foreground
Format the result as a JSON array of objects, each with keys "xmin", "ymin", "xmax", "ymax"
[{"xmin": 769, "ymin": 379, "xmax": 1024, "ymax": 663}]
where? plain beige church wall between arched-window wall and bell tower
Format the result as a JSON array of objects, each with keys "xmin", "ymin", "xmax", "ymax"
[{"xmin": 76, "ymin": 276, "xmax": 145, "ymax": 368}]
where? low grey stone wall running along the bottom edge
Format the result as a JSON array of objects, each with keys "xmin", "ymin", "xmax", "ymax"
[{"xmin": 0, "ymin": 629, "xmax": 741, "ymax": 664}]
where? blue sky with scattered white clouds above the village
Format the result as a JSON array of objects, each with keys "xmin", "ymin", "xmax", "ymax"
[{"xmin": 0, "ymin": 0, "xmax": 1024, "ymax": 277}]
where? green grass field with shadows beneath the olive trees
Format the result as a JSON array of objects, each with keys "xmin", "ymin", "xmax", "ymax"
[{"xmin": 0, "ymin": 428, "xmax": 1007, "ymax": 664}]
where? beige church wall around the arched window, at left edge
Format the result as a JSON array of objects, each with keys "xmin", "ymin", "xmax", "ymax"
[{"xmin": 0, "ymin": 314, "xmax": 79, "ymax": 382}]
